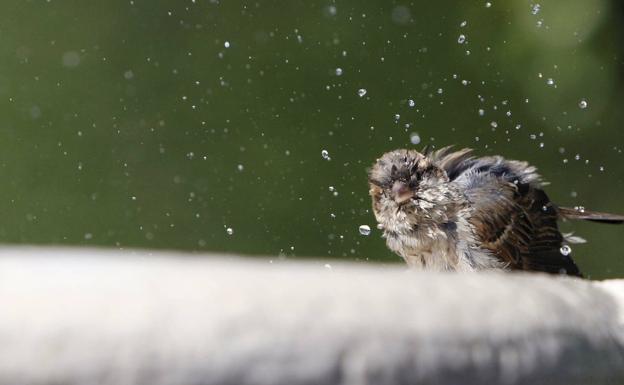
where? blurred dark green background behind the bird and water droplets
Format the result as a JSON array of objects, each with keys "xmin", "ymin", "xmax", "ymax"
[{"xmin": 0, "ymin": 0, "xmax": 624, "ymax": 278}]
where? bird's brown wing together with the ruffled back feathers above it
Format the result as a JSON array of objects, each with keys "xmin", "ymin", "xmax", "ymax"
[{"xmin": 427, "ymin": 147, "xmax": 581, "ymax": 276}]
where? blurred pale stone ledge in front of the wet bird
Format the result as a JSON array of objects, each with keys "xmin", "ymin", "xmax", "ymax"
[{"xmin": 0, "ymin": 248, "xmax": 624, "ymax": 385}]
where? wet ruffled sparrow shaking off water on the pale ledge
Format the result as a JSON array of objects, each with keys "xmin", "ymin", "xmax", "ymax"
[{"xmin": 368, "ymin": 147, "xmax": 624, "ymax": 277}]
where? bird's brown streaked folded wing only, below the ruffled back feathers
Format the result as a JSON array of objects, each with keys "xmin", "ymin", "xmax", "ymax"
[{"xmin": 460, "ymin": 165, "xmax": 581, "ymax": 276}]
